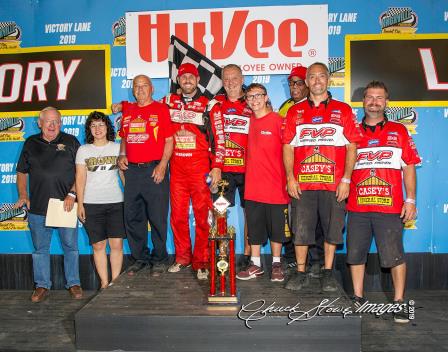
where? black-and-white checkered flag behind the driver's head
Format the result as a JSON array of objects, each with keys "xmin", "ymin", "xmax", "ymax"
[{"xmin": 168, "ymin": 35, "xmax": 224, "ymax": 99}]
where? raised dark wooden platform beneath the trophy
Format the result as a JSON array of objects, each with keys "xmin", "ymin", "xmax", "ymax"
[{"xmin": 75, "ymin": 269, "xmax": 361, "ymax": 352}]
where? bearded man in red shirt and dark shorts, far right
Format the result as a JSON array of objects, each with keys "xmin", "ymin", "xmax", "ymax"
[{"xmin": 347, "ymin": 81, "xmax": 421, "ymax": 323}]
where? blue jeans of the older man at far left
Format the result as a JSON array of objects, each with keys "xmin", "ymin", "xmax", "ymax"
[{"xmin": 28, "ymin": 214, "xmax": 80, "ymax": 289}]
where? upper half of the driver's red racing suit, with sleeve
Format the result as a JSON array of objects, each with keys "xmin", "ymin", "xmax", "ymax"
[{"xmin": 162, "ymin": 94, "xmax": 225, "ymax": 169}]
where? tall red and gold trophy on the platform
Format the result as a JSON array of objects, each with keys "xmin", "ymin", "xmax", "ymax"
[{"xmin": 208, "ymin": 180, "xmax": 239, "ymax": 304}]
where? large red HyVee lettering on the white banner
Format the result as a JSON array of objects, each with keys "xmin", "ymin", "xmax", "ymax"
[{"xmin": 138, "ymin": 10, "xmax": 308, "ymax": 62}]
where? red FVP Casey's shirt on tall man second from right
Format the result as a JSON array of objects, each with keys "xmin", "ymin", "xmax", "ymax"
[{"xmin": 283, "ymin": 96, "xmax": 361, "ymax": 191}]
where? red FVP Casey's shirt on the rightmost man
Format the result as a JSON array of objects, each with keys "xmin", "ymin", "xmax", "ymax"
[{"xmin": 347, "ymin": 121, "xmax": 421, "ymax": 214}]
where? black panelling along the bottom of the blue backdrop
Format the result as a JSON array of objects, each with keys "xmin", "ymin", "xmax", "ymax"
[{"xmin": 0, "ymin": 253, "xmax": 448, "ymax": 292}]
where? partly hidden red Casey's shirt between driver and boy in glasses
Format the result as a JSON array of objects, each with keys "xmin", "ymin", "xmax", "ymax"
[{"xmin": 215, "ymin": 94, "xmax": 252, "ymax": 173}]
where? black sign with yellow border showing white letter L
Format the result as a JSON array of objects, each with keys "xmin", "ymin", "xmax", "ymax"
[{"xmin": 345, "ymin": 33, "xmax": 448, "ymax": 107}]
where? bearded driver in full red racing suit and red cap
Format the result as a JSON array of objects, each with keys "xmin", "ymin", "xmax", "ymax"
[{"xmin": 163, "ymin": 63, "xmax": 225, "ymax": 280}]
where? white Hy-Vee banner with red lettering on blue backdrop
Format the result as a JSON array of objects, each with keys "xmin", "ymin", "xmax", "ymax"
[{"xmin": 126, "ymin": 5, "xmax": 328, "ymax": 79}]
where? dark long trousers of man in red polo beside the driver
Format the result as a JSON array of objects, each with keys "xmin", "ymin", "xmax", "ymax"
[{"xmin": 124, "ymin": 162, "xmax": 169, "ymax": 264}]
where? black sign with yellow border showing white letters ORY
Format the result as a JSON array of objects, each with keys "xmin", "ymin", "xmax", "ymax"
[{"xmin": 0, "ymin": 45, "xmax": 112, "ymax": 117}]
